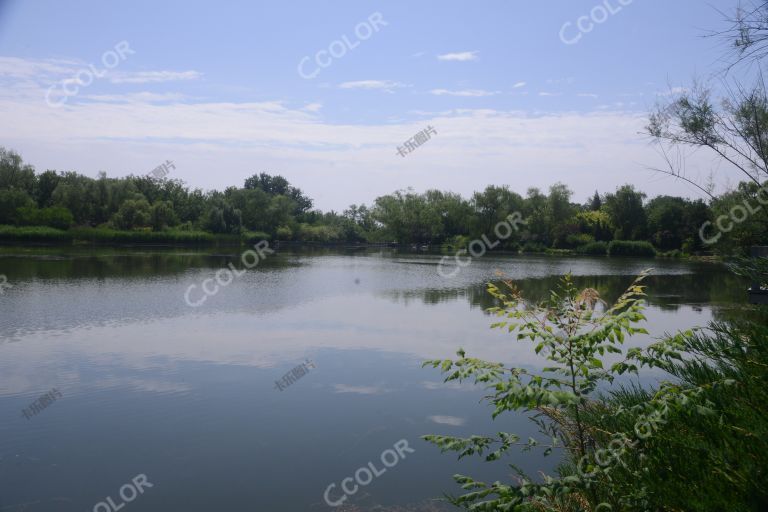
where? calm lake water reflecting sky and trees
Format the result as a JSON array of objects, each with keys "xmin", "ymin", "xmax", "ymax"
[{"xmin": 0, "ymin": 247, "xmax": 745, "ymax": 512}]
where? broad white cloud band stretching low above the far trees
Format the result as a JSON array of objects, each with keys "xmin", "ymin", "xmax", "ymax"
[{"xmin": 0, "ymin": 54, "xmax": 727, "ymax": 210}]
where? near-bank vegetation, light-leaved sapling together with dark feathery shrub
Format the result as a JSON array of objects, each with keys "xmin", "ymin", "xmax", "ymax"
[{"xmin": 425, "ymin": 259, "xmax": 768, "ymax": 512}]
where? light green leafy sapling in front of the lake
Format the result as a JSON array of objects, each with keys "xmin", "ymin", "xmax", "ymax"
[{"xmin": 424, "ymin": 271, "xmax": 706, "ymax": 511}]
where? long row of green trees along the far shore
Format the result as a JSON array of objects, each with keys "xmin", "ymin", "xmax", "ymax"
[{"xmin": 0, "ymin": 148, "xmax": 768, "ymax": 254}]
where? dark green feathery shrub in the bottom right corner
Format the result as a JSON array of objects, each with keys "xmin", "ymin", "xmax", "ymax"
[{"xmin": 583, "ymin": 321, "xmax": 768, "ymax": 512}]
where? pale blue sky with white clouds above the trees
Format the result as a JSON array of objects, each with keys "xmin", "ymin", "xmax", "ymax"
[{"xmin": 0, "ymin": 0, "xmax": 748, "ymax": 211}]
